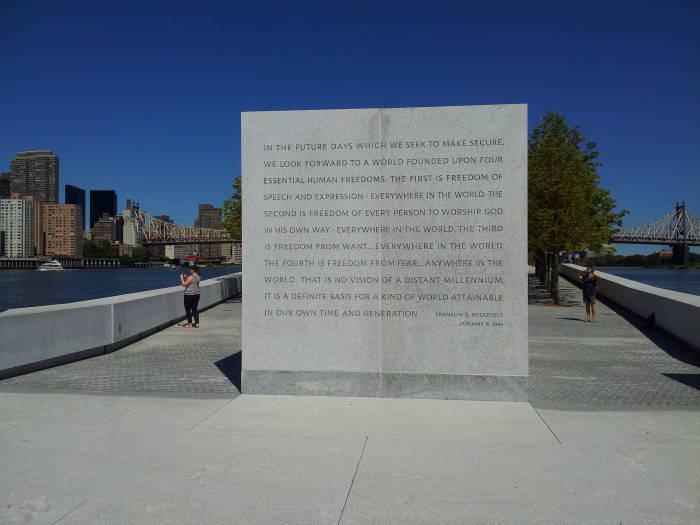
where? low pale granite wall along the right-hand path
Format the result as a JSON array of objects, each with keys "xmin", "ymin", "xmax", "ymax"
[{"xmin": 559, "ymin": 264, "xmax": 700, "ymax": 349}]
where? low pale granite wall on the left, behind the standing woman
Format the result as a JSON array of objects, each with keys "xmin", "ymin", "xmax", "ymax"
[{"xmin": 0, "ymin": 272, "xmax": 242, "ymax": 379}]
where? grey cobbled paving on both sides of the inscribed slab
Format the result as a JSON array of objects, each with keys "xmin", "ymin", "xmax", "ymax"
[{"xmin": 0, "ymin": 275, "xmax": 700, "ymax": 409}]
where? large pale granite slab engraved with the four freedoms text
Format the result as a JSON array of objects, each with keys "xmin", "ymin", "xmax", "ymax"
[{"xmin": 242, "ymin": 105, "xmax": 528, "ymax": 400}]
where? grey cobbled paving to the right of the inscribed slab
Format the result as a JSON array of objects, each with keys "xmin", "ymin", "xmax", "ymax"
[{"xmin": 529, "ymin": 275, "xmax": 700, "ymax": 409}]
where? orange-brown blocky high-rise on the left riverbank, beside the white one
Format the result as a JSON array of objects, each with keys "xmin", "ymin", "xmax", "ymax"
[{"xmin": 39, "ymin": 203, "xmax": 83, "ymax": 257}]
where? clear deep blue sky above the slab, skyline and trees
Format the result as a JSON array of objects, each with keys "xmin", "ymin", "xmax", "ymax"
[{"xmin": 0, "ymin": 0, "xmax": 700, "ymax": 253}]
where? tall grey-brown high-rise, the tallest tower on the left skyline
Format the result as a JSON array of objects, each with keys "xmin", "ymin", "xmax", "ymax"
[{"xmin": 10, "ymin": 150, "xmax": 58, "ymax": 204}]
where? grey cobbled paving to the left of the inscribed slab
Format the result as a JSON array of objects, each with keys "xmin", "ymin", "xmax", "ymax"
[{"xmin": 0, "ymin": 299, "xmax": 241, "ymax": 397}]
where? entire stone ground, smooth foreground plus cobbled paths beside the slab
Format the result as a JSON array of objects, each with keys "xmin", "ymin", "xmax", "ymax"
[{"xmin": 0, "ymin": 280, "xmax": 700, "ymax": 525}]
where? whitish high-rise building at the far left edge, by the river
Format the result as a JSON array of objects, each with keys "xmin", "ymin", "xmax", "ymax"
[{"xmin": 0, "ymin": 199, "xmax": 34, "ymax": 257}]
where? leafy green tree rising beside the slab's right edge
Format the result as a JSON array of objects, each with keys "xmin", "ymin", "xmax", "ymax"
[{"xmin": 528, "ymin": 111, "xmax": 626, "ymax": 301}]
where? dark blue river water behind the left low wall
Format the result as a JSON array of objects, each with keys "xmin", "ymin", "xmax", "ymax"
[{"xmin": 0, "ymin": 267, "xmax": 240, "ymax": 312}]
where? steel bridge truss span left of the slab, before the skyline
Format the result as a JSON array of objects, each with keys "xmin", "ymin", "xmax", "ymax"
[{"xmin": 132, "ymin": 210, "xmax": 240, "ymax": 246}]
